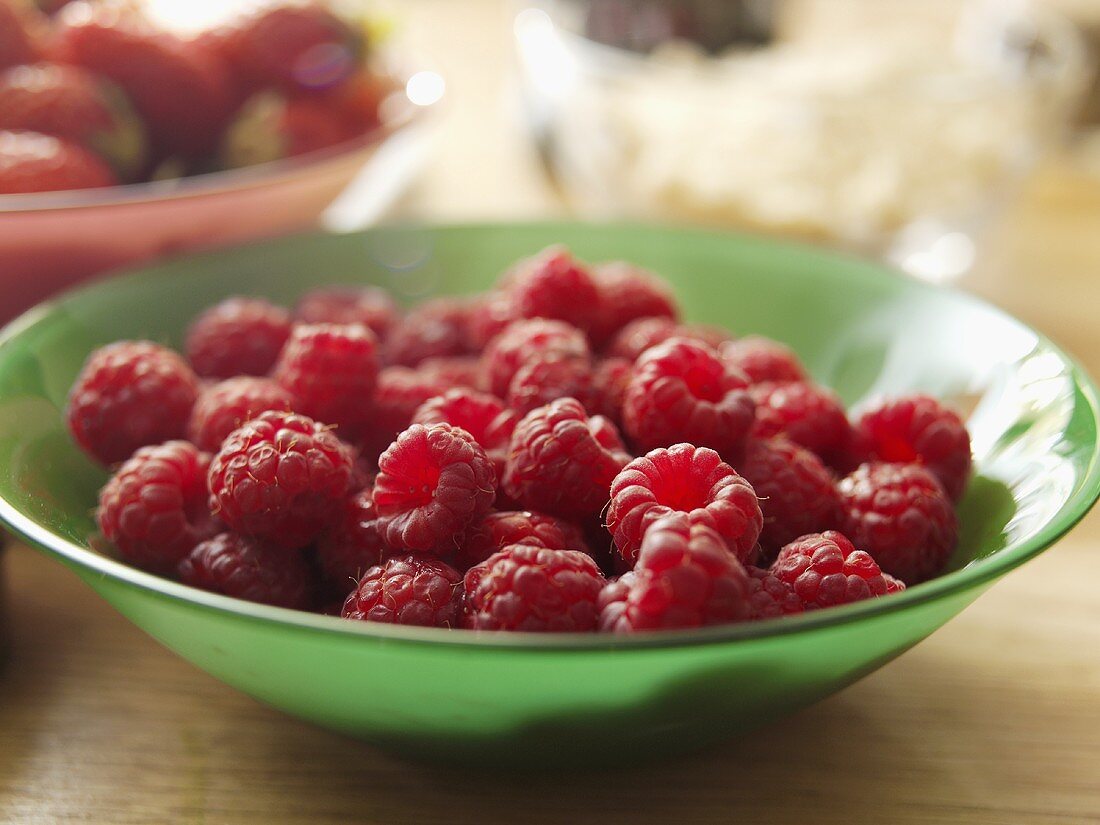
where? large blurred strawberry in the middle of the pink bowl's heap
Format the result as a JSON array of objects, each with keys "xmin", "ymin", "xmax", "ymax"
[{"xmin": 53, "ymin": 0, "xmax": 232, "ymax": 158}]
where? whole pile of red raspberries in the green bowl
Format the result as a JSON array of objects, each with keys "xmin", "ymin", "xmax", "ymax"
[{"xmin": 67, "ymin": 248, "xmax": 971, "ymax": 634}]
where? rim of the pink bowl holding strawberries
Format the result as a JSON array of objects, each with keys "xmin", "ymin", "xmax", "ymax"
[{"xmin": 0, "ymin": 76, "xmax": 440, "ymax": 218}]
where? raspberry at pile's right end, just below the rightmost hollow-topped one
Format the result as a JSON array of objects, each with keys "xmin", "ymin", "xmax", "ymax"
[{"xmin": 837, "ymin": 464, "xmax": 958, "ymax": 584}]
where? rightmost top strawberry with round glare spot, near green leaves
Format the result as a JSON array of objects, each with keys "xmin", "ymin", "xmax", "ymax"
[{"xmin": 207, "ymin": 0, "xmax": 364, "ymax": 94}]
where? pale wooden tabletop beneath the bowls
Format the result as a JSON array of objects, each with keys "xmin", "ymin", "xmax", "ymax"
[{"xmin": 0, "ymin": 2, "xmax": 1100, "ymax": 825}]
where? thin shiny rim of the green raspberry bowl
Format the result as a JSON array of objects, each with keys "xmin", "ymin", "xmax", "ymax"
[{"xmin": 0, "ymin": 220, "xmax": 1100, "ymax": 652}]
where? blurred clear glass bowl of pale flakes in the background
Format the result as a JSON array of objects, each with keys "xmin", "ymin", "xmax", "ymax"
[{"xmin": 514, "ymin": 0, "xmax": 1089, "ymax": 279}]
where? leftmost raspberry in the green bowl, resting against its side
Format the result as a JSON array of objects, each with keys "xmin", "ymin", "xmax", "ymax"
[{"xmin": 66, "ymin": 341, "xmax": 199, "ymax": 464}]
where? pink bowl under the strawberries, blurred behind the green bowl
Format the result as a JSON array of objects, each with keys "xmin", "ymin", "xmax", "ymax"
[{"xmin": 0, "ymin": 83, "xmax": 427, "ymax": 323}]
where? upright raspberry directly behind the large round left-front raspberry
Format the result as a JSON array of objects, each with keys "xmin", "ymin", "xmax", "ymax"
[{"xmin": 274, "ymin": 323, "xmax": 378, "ymax": 435}]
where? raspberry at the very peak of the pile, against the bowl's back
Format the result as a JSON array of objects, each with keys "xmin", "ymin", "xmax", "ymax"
[{"xmin": 509, "ymin": 246, "xmax": 600, "ymax": 331}]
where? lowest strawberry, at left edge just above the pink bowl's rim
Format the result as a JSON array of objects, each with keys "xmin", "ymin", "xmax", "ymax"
[{"xmin": 0, "ymin": 132, "xmax": 118, "ymax": 195}]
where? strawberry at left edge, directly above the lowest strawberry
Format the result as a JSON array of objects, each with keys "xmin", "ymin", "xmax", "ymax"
[{"xmin": 0, "ymin": 63, "xmax": 145, "ymax": 180}]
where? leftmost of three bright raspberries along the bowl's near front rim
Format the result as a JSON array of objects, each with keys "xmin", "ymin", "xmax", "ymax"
[{"xmin": 340, "ymin": 556, "xmax": 462, "ymax": 627}]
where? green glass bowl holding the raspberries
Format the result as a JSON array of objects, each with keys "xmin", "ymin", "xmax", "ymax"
[{"xmin": 0, "ymin": 223, "xmax": 1100, "ymax": 766}]
